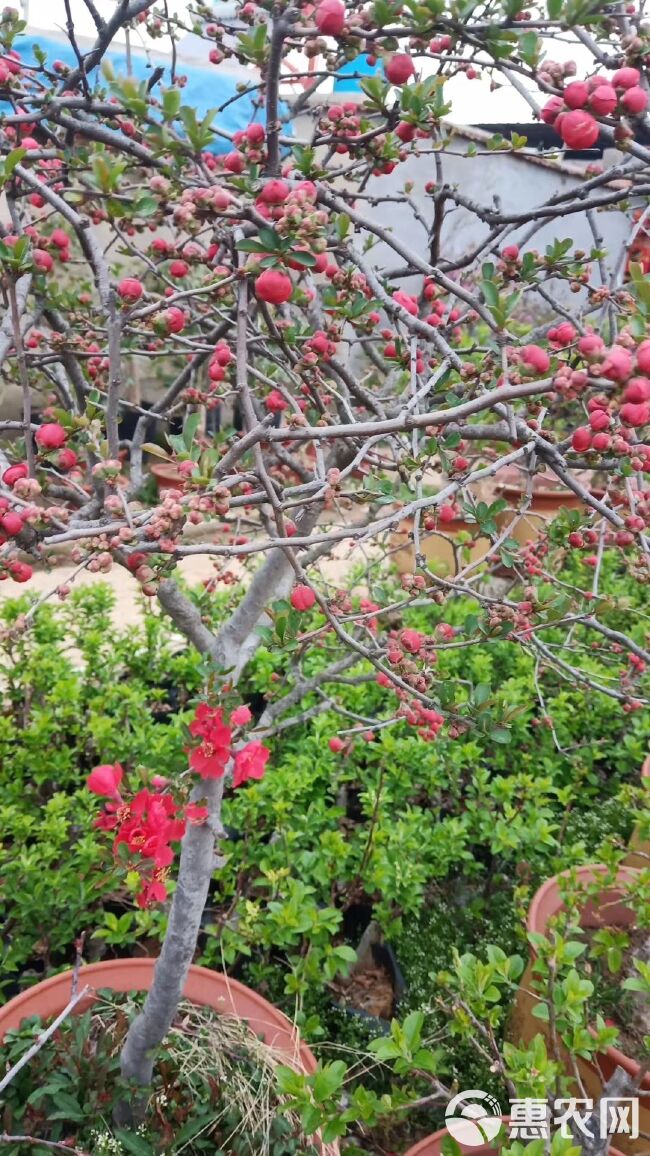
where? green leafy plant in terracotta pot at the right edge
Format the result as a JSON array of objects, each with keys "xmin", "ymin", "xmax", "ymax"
[{"xmin": 509, "ymin": 865, "xmax": 650, "ymax": 1153}]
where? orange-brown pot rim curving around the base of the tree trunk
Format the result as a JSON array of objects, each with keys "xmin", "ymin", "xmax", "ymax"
[{"xmin": 0, "ymin": 959, "xmax": 316, "ymax": 1075}]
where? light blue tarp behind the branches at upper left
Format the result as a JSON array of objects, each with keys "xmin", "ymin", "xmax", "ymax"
[{"xmin": 15, "ymin": 32, "xmax": 263, "ymax": 153}]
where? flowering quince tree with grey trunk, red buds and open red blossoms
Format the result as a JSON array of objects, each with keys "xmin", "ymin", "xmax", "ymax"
[{"xmin": 0, "ymin": 0, "xmax": 650, "ymax": 1105}]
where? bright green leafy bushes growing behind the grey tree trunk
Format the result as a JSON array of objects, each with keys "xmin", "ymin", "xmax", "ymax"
[{"xmin": 0, "ymin": 579, "xmax": 650, "ymax": 1030}]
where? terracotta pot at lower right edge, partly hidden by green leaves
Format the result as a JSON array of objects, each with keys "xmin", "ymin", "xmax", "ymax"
[{"xmin": 508, "ymin": 864, "xmax": 650, "ymax": 1156}]
